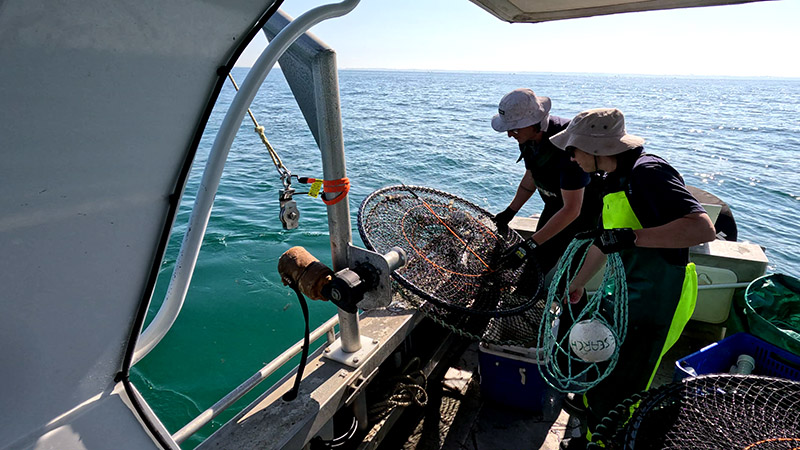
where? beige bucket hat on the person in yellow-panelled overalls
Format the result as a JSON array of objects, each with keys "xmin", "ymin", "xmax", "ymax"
[{"xmin": 550, "ymin": 108, "xmax": 644, "ymax": 156}]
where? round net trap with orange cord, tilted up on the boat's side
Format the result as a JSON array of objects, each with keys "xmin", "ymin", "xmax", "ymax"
[{"xmin": 358, "ymin": 185, "xmax": 544, "ymax": 345}]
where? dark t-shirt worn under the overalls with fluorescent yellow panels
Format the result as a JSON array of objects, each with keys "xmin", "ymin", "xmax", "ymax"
[{"xmin": 606, "ymin": 152, "xmax": 705, "ymax": 265}]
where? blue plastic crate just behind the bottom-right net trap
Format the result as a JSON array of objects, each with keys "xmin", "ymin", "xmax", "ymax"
[{"xmin": 674, "ymin": 333, "xmax": 800, "ymax": 381}]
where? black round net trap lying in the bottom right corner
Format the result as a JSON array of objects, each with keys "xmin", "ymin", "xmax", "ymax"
[{"xmin": 598, "ymin": 374, "xmax": 800, "ymax": 450}]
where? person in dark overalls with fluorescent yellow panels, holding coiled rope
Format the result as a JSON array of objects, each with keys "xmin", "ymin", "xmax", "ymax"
[{"xmin": 550, "ymin": 108, "xmax": 716, "ymax": 449}]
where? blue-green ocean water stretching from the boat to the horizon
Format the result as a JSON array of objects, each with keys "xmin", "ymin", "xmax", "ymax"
[{"xmin": 132, "ymin": 69, "xmax": 800, "ymax": 448}]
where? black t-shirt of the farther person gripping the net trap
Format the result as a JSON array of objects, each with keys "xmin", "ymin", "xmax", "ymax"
[{"xmin": 517, "ymin": 116, "xmax": 590, "ymax": 204}]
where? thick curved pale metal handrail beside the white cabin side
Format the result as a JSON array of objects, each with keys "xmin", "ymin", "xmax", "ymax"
[{"xmin": 131, "ymin": 0, "xmax": 360, "ymax": 364}]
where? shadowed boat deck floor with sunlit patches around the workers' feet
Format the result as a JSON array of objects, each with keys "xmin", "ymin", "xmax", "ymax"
[{"xmin": 368, "ymin": 322, "xmax": 724, "ymax": 450}]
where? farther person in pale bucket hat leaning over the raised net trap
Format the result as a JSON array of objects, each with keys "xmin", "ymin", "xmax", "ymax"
[{"xmin": 492, "ymin": 88, "xmax": 600, "ymax": 273}]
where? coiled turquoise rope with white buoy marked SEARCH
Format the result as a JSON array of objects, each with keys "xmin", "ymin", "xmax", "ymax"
[{"xmin": 537, "ymin": 238, "xmax": 628, "ymax": 393}]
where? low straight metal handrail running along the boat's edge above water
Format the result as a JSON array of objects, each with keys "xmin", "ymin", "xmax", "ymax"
[{"xmin": 172, "ymin": 316, "xmax": 339, "ymax": 444}]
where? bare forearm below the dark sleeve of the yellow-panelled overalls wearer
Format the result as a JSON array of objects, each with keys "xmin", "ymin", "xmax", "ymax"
[{"xmin": 634, "ymin": 213, "xmax": 717, "ymax": 248}]
